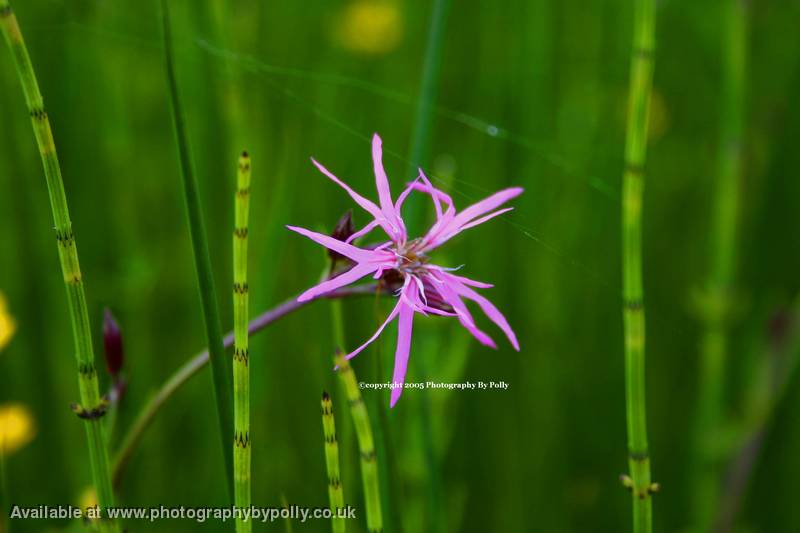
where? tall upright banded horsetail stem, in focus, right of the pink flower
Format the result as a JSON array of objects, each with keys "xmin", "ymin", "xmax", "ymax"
[{"xmin": 622, "ymin": 0, "xmax": 657, "ymax": 533}]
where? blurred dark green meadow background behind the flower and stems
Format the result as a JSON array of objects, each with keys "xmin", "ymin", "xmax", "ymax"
[{"xmin": 0, "ymin": 0, "xmax": 800, "ymax": 532}]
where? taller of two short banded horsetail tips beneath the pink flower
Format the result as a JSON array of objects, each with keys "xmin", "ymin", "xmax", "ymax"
[{"xmin": 334, "ymin": 351, "xmax": 383, "ymax": 533}]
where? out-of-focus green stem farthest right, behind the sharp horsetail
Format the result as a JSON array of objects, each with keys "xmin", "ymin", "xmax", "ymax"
[{"xmin": 692, "ymin": 0, "xmax": 747, "ymax": 531}]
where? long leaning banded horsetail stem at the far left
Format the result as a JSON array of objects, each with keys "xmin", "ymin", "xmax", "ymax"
[{"xmin": 0, "ymin": 0, "xmax": 119, "ymax": 531}]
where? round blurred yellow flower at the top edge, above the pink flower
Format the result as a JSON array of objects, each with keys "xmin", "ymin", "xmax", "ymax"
[{"xmin": 334, "ymin": 0, "xmax": 403, "ymax": 55}]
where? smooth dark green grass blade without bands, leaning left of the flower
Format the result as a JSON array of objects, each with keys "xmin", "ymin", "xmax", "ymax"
[{"xmin": 161, "ymin": 0, "xmax": 234, "ymax": 495}]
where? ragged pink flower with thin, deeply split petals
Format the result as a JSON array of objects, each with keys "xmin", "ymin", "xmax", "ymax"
[{"xmin": 287, "ymin": 134, "xmax": 522, "ymax": 407}]
